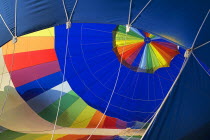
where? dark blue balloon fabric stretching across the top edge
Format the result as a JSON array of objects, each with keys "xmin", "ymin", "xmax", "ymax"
[{"xmin": 0, "ymin": 0, "xmax": 210, "ymax": 48}]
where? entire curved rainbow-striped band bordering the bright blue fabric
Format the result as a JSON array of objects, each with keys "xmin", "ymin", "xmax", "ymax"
[{"xmin": 2, "ymin": 28, "xmax": 135, "ymax": 133}]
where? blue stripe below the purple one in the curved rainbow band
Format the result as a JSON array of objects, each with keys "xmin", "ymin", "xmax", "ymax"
[{"xmin": 16, "ymin": 72, "xmax": 63, "ymax": 101}]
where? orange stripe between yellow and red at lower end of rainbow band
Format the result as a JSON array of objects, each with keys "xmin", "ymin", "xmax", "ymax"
[{"xmin": 86, "ymin": 111, "xmax": 106, "ymax": 128}]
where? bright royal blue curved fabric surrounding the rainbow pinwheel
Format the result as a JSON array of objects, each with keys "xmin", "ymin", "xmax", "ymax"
[{"xmin": 55, "ymin": 24, "xmax": 183, "ymax": 122}]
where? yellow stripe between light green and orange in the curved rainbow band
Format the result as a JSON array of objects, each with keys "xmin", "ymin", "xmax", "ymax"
[{"xmin": 71, "ymin": 106, "xmax": 96, "ymax": 128}]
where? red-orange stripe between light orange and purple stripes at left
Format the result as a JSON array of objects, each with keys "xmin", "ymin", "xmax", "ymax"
[{"xmin": 4, "ymin": 49, "xmax": 57, "ymax": 71}]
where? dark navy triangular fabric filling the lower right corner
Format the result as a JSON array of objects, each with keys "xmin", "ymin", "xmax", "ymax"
[{"xmin": 143, "ymin": 56, "xmax": 210, "ymax": 140}]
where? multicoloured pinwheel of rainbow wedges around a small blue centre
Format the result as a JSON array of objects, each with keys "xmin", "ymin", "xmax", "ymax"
[{"xmin": 113, "ymin": 25, "xmax": 179, "ymax": 73}]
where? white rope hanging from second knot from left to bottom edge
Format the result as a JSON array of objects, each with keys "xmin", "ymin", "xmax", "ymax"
[{"xmin": 51, "ymin": 29, "xmax": 69, "ymax": 140}]
